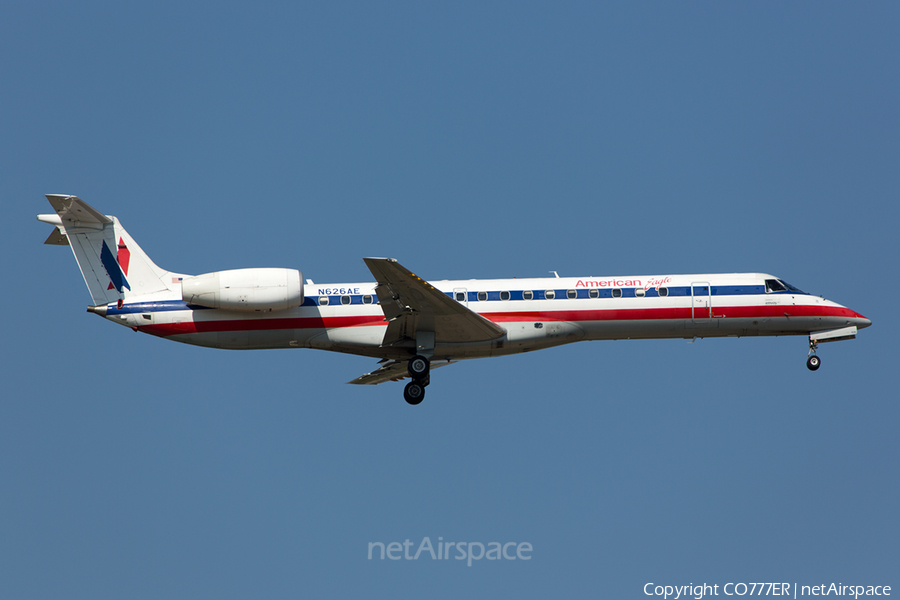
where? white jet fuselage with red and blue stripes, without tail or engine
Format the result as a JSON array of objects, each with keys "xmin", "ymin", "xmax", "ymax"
[{"xmin": 106, "ymin": 273, "xmax": 870, "ymax": 360}]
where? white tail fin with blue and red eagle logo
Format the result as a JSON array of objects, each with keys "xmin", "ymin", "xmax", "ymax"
[{"xmin": 38, "ymin": 194, "xmax": 172, "ymax": 305}]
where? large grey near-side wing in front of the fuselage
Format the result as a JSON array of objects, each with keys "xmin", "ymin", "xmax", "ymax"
[{"xmin": 363, "ymin": 258, "xmax": 506, "ymax": 346}]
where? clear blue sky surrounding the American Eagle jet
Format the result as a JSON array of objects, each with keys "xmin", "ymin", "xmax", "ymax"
[{"xmin": 0, "ymin": 2, "xmax": 900, "ymax": 599}]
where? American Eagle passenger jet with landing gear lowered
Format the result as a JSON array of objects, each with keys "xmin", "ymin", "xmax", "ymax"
[{"xmin": 37, "ymin": 194, "xmax": 872, "ymax": 405}]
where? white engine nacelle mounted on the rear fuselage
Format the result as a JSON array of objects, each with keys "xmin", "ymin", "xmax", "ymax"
[{"xmin": 181, "ymin": 269, "xmax": 303, "ymax": 312}]
